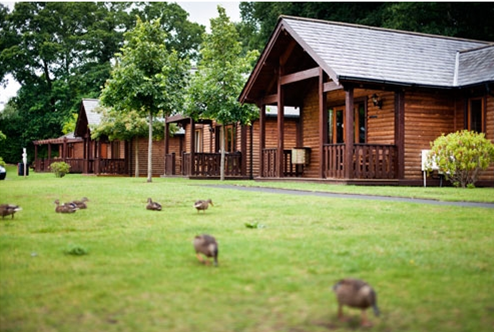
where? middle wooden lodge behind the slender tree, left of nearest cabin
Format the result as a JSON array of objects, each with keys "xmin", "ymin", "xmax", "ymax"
[{"xmin": 165, "ymin": 109, "xmax": 298, "ymax": 179}]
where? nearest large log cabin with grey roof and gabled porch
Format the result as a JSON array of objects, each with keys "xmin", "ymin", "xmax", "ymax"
[{"xmin": 238, "ymin": 16, "xmax": 494, "ymax": 186}]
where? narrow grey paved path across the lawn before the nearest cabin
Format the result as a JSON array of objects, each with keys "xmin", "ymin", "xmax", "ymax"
[{"xmin": 207, "ymin": 184, "xmax": 494, "ymax": 209}]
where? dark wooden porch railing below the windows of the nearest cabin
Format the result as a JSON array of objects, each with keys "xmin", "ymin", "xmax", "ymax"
[{"xmin": 324, "ymin": 144, "xmax": 397, "ymax": 179}]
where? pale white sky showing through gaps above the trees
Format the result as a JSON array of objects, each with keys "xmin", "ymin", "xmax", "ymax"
[{"xmin": 0, "ymin": 0, "xmax": 240, "ymax": 111}]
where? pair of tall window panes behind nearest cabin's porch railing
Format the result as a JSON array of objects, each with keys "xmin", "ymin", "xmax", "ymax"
[{"xmin": 328, "ymin": 102, "xmax": 367, "ymax": 144}]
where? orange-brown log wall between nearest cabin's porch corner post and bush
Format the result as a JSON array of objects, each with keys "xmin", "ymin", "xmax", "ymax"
[{"xmin": 404, "ymin": 92, "xmax": 457, "ymax": 180}]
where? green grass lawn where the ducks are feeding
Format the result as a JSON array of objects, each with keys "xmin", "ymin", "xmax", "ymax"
[{"xmin": 0, "ymin": 168, "xmax": 494, "ymax": 332}]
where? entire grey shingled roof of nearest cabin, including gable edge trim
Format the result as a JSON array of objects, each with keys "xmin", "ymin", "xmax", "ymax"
[{"xmin": 240, "ymin": 16, "xmax": 494, "ymax": 104}]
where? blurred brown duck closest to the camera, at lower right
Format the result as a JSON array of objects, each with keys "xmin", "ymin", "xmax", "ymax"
[{"xmin": 333, "ymin": 278, "xmax": 380, "ymax": 327}]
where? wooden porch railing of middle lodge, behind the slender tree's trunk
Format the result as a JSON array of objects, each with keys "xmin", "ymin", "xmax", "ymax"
[{"xmin": 182, "ymin": 152, "xmax": 242, "ymax": 177}]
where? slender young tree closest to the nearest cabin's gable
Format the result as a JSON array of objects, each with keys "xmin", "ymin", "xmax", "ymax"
[{"xmin": 188, "ymin": 6, "xmax": 258, "ymax": 180}]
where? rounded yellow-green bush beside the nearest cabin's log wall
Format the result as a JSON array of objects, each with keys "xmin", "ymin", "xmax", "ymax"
[{"xmin": 428, "ymin": 130, "xmax": 494, "ymax": 188}]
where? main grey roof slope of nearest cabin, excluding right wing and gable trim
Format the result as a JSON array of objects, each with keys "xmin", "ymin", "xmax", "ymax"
[{"xmin": 281, "ymin": 17, "xmax": 492, "ymax": 87}]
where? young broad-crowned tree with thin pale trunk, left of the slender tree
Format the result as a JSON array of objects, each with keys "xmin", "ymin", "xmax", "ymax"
[{"xmin": 101, "ymin": 18, "xmax": 188, "ymax": 182}]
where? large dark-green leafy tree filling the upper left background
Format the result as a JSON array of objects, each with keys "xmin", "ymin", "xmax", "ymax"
[{"xmin": 0, "ymin": 2, "xmax": 204, "ymax": 162}]
